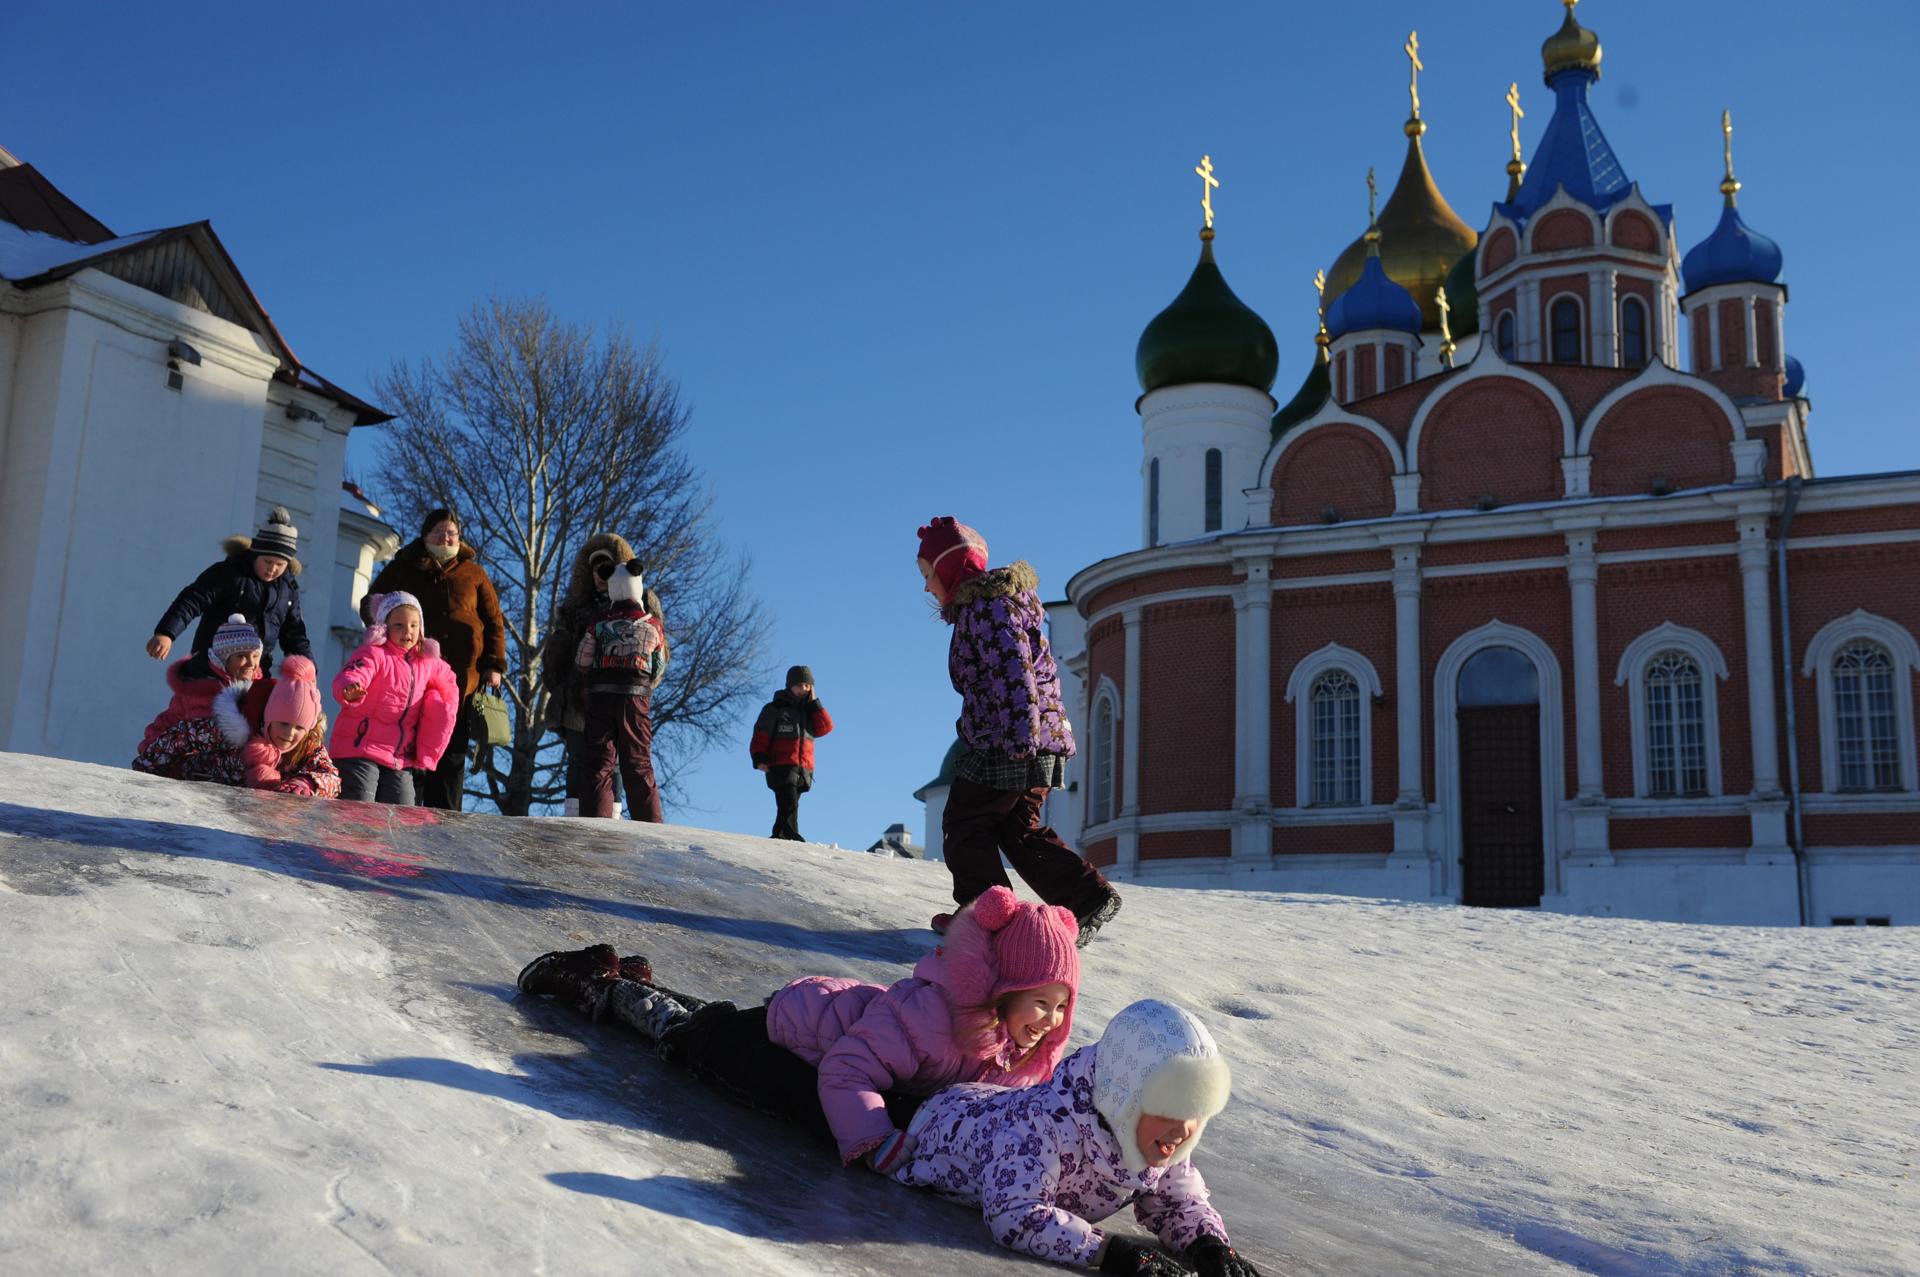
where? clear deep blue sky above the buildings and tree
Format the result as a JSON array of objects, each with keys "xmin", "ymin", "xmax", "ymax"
[{"xmin": 0, "ymin": 0, "xmax": 1920, "ymax": 845}]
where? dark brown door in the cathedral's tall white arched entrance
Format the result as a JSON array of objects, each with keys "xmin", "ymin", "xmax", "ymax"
[{"xmin": 1459, "ymin": 705, "xmax": 1546, "ymax": 908}]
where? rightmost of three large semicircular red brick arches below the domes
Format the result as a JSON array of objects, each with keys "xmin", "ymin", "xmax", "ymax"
[{"xmin": 1588, "ymin": 386, "xmax": 1734, "ymax": 495}]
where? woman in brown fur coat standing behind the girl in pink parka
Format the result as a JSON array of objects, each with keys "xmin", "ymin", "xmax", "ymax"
[{"xmin": 371, "ymin": 509, "xmax": 507, "ymax": 812}]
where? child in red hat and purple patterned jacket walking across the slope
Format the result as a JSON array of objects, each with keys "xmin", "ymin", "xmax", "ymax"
[{"xmin": 920, "ymin": 515, "xmax": 1119, "ymax": 945}]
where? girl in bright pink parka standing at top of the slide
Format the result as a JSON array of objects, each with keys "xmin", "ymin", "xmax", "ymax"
[{"xmin": 330, "ymin": 590, "xmax": 461, "ymax": 807}]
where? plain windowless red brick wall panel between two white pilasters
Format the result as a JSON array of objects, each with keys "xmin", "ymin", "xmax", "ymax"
[{"xmin": 1140, "ymin": 599, "xmax": 1235, "ymax": 806}]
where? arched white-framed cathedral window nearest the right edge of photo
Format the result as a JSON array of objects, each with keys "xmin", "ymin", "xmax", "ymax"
[{"xmin": 1801, "ymin": 609, "xmax": 1920, "ymax": 793}]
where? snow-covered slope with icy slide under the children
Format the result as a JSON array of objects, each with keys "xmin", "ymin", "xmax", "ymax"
[{"xmin": 0, "ymin": 755, "xmax": 1920, "ymax": 1277}]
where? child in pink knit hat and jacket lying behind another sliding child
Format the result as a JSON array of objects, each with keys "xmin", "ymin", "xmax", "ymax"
[{"xmin": 520, "ymin": 887, "xmax": 1079, "ymax": 1173}]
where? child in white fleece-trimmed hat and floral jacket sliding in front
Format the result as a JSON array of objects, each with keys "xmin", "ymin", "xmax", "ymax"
[{"xmin": 893, "ymin": 1000, "xmax": 1260, "ymax": 1277}]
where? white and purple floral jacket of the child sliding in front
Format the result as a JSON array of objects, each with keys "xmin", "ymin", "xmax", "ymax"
[{"xmin": 893, "ymin": 1043, "xmax": 1231, "ymax": 1265}]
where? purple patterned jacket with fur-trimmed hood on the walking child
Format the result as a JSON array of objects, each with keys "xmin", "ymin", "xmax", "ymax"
[{"xmin": 947, "ymin": 561, "xmax": 1073, "ymax": 759}]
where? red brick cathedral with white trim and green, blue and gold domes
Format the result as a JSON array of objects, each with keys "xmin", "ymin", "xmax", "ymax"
[{"xmin": 1068, "ymin": 4, "xmax": 1920, "ymax": 926}]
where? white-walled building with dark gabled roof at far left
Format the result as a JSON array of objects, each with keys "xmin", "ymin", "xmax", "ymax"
[{"xmin": 0, "ymin": 150, "xmax": 392, "ymax": 762}]
